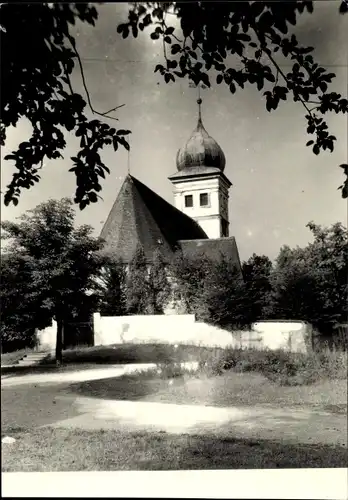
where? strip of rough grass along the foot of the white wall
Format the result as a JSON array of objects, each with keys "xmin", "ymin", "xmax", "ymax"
[{"xmin": 2, "ymin": 343, "xmax": 348, "ymax": 386}]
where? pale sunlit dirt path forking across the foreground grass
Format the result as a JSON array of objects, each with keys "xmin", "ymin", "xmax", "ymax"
[{"xmin": 1, "ymin": 365, "xmax": 347, "ymax": 446}]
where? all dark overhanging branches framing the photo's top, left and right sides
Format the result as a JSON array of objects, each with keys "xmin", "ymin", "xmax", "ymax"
[{"xmin": 0, "ymin": 0, "xmax": 348, "ymax": 205}]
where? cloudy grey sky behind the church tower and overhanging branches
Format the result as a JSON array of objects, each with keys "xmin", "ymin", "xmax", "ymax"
[{"xmin": 1, "ymin": 0, "xmax": 348, "ymax": 260}]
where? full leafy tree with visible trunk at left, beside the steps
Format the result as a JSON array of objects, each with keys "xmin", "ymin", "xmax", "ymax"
[{"xmin": 1, "ymin": 198, "xmax": 104, "ymax": 364}]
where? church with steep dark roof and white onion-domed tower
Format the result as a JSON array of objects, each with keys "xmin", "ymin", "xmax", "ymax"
[{"xmin": 100, "ymin": 98, "xmax": 241, "ymax": 278}]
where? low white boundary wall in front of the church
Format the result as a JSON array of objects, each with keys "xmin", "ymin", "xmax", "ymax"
[{"xmin": 38, "ymin": 313, "xmax": 311, "ymax": 352}]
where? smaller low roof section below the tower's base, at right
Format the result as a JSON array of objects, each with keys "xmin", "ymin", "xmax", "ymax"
[{"xmin": 179, "ymin": 236, "xmax": 242, "ymax": 273}]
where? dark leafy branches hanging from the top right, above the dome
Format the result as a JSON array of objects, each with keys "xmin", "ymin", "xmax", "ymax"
[{"xmin": 117, "ymin": 0, "xmax": 348, "ymax": 198}]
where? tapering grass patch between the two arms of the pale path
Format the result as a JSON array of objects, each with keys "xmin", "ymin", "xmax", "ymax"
[{"xmin": 69, "ymin": 371, "xmax": 347, "ymax": 413}]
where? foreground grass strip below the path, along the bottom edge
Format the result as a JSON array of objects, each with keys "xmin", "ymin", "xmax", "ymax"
[{"xmin": 1, "ymin": 428, "xmax": 347, "ymax": 472}]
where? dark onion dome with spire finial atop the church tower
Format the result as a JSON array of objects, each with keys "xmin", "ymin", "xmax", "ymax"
[{"xmin": 176, "ymin": 99, "xmax": 226, "ymax": 172}]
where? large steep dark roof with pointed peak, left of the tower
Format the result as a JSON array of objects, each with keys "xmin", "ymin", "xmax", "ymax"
[{"xmin": 100, "ymin": 175, "xmax": 208, "ymax": 262}]
